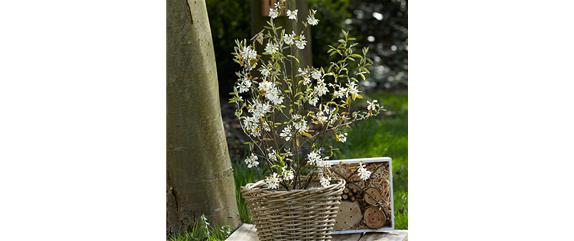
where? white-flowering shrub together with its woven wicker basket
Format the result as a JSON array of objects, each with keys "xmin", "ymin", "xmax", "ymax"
[{"xmin": 230, "ymin": 0, "xmax": 380, "ymax": 240}]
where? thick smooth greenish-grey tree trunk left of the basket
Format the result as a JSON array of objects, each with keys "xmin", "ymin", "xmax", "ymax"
[{"xmin": 166, "ymin": 0, "xmax": 241, "ymax": 234}]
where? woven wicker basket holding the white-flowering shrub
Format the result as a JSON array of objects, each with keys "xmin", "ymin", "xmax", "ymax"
[{"xmin": 241, "ymin": 179, "xmax": 345, "ymax": 241}]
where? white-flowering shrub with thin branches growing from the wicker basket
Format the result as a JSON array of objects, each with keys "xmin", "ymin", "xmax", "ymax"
[{"xmin": 230, "ymin": 0, "xmax": 380, "ymax": 190}]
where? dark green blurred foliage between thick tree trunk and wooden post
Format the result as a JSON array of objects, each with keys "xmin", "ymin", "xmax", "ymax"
[{"xmin": 206, "ymin": 0, "xmax": 251, "ymax": 96}]
